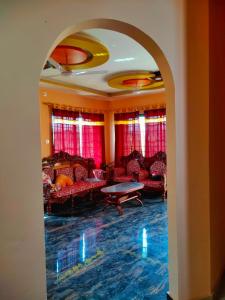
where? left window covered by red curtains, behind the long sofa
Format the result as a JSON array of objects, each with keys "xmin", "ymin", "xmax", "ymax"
[{"xmin": 52, "ymin": 109, "xmax": 105, "ymax": 167}]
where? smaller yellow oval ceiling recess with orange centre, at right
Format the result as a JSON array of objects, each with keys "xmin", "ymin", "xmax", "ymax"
[{"xmin": 108, "ymin": 71, "xmax": 164, "ymax": 90}]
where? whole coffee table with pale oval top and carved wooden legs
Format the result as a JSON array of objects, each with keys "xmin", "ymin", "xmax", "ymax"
[{"xmin": 101, "ymin": 182, "xmax": 144, "ymax": 215}]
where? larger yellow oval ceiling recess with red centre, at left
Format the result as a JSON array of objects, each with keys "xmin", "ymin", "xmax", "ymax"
[{"xmin": 51, "ymin": 34, "xmax": 109, "ymax": 71}]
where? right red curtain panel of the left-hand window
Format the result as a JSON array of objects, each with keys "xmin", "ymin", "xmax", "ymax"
[{"xmin": 81, "ymin": 113, "xmax": 105, "ymax": 168}]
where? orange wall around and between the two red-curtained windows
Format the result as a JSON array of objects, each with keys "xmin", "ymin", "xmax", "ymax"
[{"xmin": 39, "ymin": 87, "xmax": 166, "ymax": 162}]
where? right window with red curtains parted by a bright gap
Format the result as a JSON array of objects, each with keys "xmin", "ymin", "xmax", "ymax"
[{"xmin": 114, "ymin": 109, "xmax": 166, "ymax": 161}]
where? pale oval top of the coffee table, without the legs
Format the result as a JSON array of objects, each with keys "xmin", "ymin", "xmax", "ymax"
[{"xmin": 101, "ymin": 182, "xmax": 144, "ymax": 195}]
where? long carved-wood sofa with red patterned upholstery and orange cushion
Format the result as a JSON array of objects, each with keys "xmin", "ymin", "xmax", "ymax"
[{"xmin": 42, "ymin": 151, "xmax": 107, "ymax": 213}]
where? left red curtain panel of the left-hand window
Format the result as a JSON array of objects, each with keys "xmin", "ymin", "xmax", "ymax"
[{"xmin": 52, "ymin": 109, "xmax": 80, "ymax": 155}]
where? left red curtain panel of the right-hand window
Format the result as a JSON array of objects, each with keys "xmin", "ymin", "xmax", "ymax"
[{"xmin": 114, "ymin": 112, "xmax": 141, "ymax": 162}]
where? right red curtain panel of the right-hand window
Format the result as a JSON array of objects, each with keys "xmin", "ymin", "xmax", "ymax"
[{"xmin": 144, "ymin": 109, "xmax": 166, "ymax": 157}]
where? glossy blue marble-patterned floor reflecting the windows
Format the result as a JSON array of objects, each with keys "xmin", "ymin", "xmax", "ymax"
[{"xmin": 45, "ymin": 199, "xmax": 168, "ymax": 300}]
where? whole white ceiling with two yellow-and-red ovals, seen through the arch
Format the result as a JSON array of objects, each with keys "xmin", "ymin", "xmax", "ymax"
[{"xmin": 40, "ymin": 29, "xmax": 164, "ymax": 101}]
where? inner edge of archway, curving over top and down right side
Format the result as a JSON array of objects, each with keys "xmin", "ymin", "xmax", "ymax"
[{"xmin": 41, "ymin": 19, "xmax": 177, "ymax": 300}]
